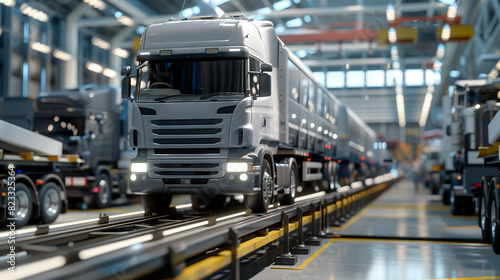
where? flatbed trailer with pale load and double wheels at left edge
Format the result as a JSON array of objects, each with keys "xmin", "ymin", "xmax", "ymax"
[{"xmin": 0, "ymin": 120, "xmax": 75, "ymax": 228}]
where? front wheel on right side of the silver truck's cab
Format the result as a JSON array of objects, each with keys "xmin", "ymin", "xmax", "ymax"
[{"xmin": 246, "ymin": 159, "xmax": 274, "ymax": 213}]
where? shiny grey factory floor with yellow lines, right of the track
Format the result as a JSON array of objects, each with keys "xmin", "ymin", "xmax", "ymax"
[{"xmin": 252, "ymin": 180, "xmax": 500, "ymax": 280}]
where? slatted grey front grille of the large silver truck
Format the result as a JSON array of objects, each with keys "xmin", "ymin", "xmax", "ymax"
[{"xmin": 142, "ymin": 103, "xmax": 235, "ymax": 182}]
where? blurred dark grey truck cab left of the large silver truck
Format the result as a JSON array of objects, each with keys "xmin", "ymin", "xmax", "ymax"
[{"xmin": 33, "ymin": 85, "xmax": 136, "ymax": 208}]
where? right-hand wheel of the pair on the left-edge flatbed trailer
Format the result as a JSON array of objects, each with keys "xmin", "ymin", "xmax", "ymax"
[{"xmin": 40, "ymin": 183, "xmax": 62, "ymax": 224}]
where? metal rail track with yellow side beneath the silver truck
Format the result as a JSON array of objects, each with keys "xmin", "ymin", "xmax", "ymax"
[{"xmin": 0, "ymin": 176, "xmax": 398, "ymax": 279}]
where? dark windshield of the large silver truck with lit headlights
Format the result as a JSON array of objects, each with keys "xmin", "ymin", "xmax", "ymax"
[{"xmin": 138, "ymin": 59, "xmax": 245, "ymax": 102}]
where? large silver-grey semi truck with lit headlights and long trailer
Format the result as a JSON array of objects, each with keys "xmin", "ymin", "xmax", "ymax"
[{"xmin": 122, "ymin": 17, "xmax": 375, "ymax": 214}]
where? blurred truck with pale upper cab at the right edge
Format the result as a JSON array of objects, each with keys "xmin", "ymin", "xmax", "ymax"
[{"xmin": 447, "ymin": 80, "xmax": 497, "ymax": 215}]
